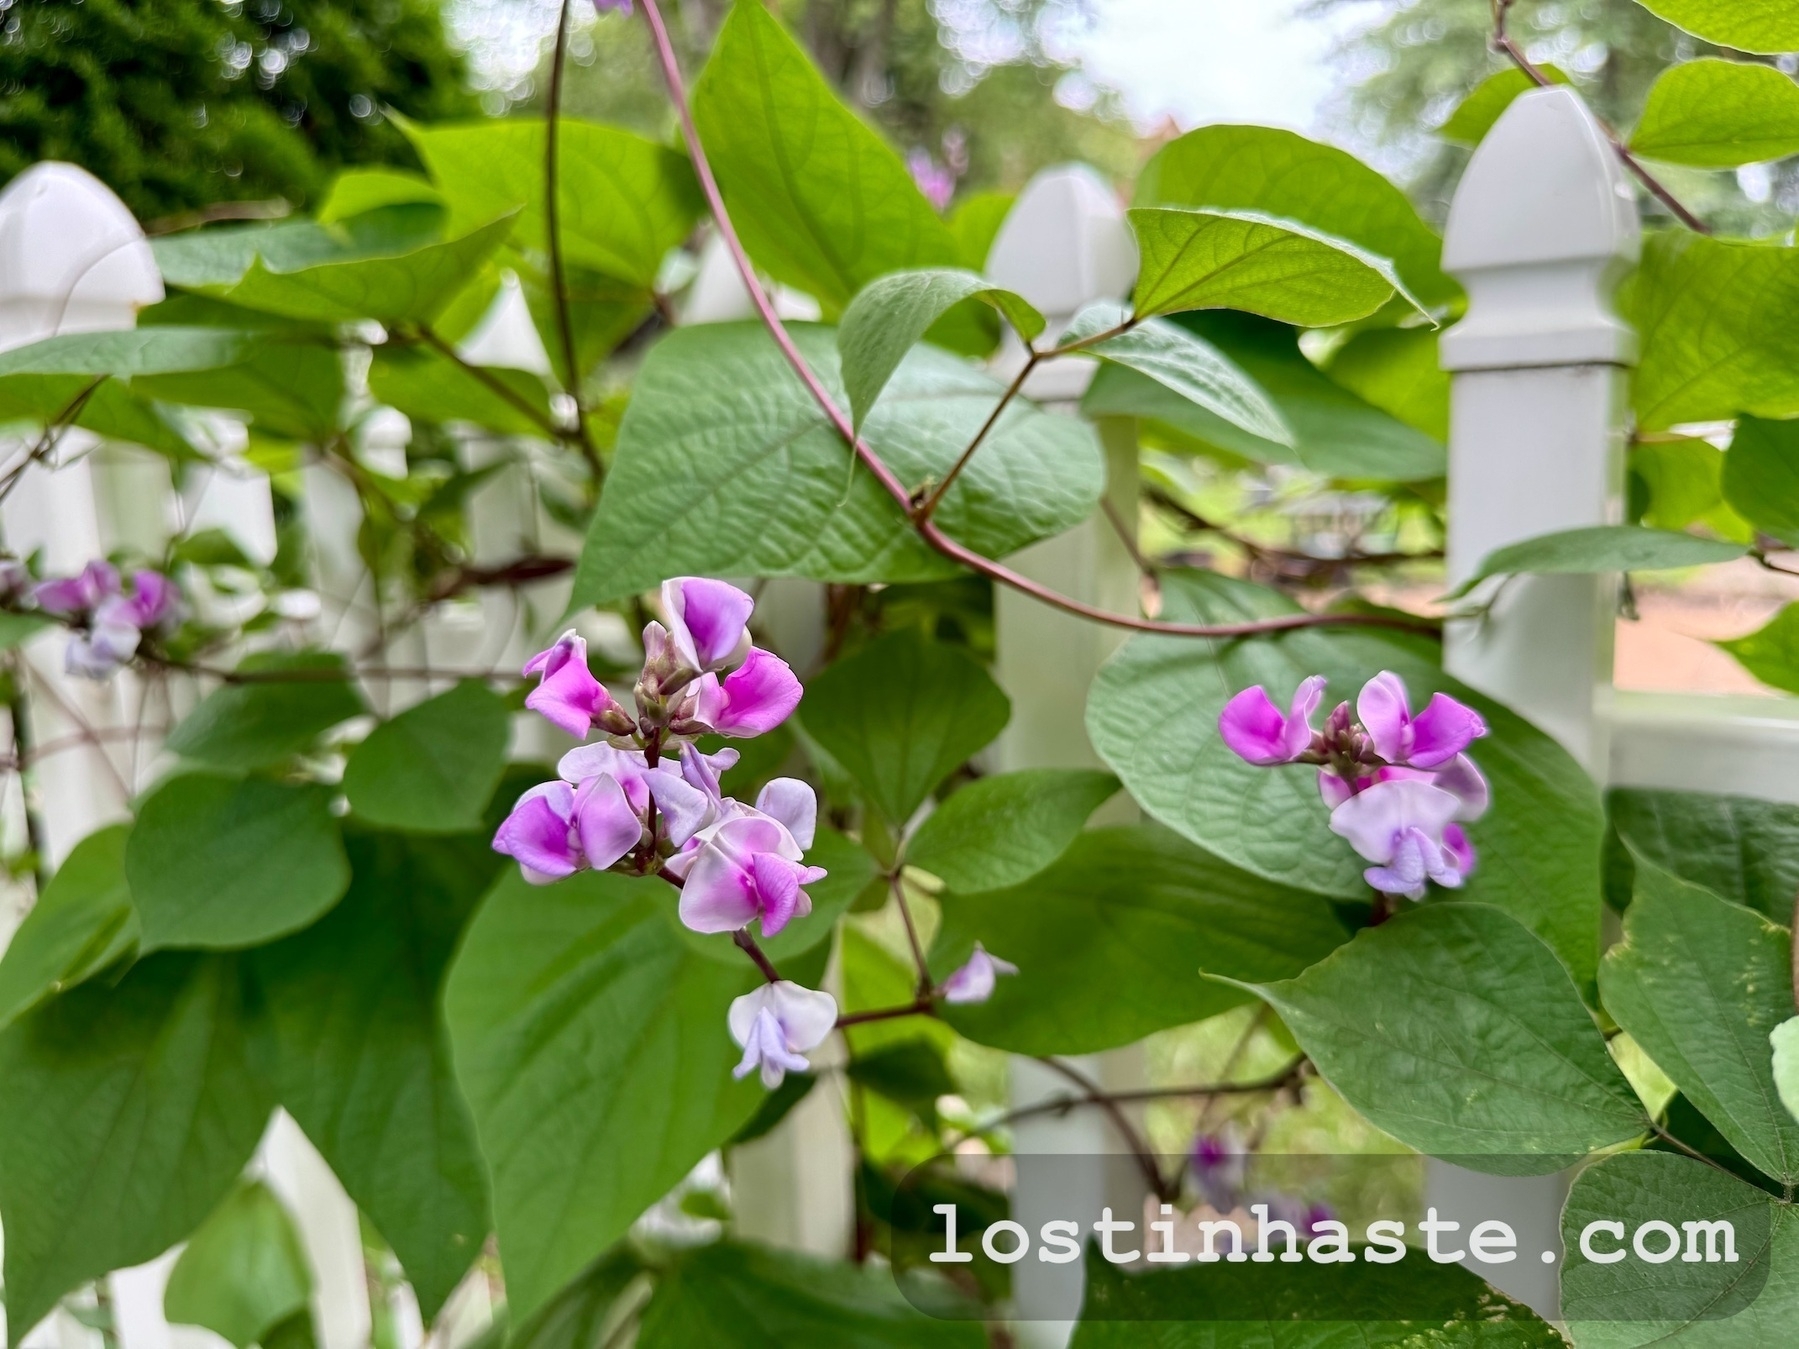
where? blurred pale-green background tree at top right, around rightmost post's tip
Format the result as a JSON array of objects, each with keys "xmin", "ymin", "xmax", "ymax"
[{"xmin": 1304, "ymin": 0, "xmax": 1799, "ymax": 234}]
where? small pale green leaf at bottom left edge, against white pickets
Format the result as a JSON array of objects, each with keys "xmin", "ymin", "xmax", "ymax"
[{"xmin": 162, "ymin": 1180, "xmax": 313, "ymax": 1349}]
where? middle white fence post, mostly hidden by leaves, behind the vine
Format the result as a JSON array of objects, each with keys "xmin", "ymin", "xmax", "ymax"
[{"xmin": 988, "ymin": 165, "xmax": 1142, "ymax": 1349}]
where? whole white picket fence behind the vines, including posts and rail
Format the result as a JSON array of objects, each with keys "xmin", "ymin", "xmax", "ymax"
[{"xmin": 0, "ymin": 88, "xmax": 1799, "ymax": 1349}]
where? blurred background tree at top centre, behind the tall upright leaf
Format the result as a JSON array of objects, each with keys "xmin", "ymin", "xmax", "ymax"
[{"xmin": 531, "ymin": 0, "xmax": 1141, "ymax": 194}]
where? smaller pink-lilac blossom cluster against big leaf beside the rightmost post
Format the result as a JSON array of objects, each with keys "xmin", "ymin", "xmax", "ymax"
[{"xmin": 1218, "ymin": 671, "xmax": 1488, "ymax": 899}]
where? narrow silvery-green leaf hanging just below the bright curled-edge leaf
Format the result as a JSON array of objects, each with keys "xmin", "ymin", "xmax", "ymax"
[{"xmin": 1061, "ymin": 300, "xmax": 1293, "ymax": 446}]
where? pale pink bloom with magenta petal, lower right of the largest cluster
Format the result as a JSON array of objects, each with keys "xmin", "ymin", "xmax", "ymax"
[{"xmin": 664, "ymin": 777, "xmax": 826, "ymax": 937}]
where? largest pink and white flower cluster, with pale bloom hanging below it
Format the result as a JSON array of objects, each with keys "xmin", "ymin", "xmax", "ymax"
[{"xmin": 493, "ymin": 577, "xmax": 837, "ymax": 1086}]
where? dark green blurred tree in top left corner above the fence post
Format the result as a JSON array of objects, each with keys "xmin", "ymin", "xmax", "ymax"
[{"xmin": 0, "ymin": 0, "xmax": 477, "ymax": 219}]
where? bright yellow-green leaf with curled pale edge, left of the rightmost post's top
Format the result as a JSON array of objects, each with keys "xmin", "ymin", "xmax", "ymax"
[{"xmin": 1130, "ymin": 207, "xmax": 1423, "ymax": 327}]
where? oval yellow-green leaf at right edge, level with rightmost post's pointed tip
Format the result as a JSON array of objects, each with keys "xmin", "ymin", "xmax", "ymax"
[{"xmin": 1630, "ymin": 58, "xmax": 1799, "ymax": 169}]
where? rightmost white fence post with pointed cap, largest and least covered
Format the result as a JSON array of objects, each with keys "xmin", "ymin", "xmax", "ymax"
[{"xmin": 1427, "ymin": 88, "xmax": 1639, "ymax": 1315}]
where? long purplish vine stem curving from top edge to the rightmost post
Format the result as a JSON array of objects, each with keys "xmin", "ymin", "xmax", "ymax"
[{"xmin": 644, "ymin": 0, "xmax": 1439, "ymax": 637}]
